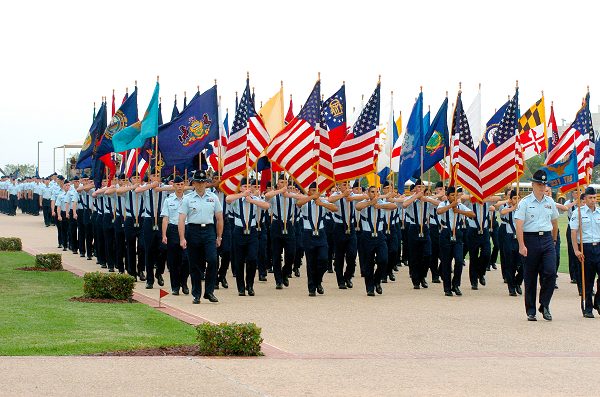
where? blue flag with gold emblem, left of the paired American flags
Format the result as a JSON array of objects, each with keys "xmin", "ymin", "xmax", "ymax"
[{"xmin": 413, "ymin": 98, "xmax": 450, "ymax": 178}]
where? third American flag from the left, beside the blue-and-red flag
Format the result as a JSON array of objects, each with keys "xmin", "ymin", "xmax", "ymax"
[{"xmin": 333, "ymin": 83, "xmax": 381, "ymax": 181}]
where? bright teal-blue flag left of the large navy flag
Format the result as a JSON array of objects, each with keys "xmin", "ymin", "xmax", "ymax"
[{"xmin": 112, "ymin": 82, "xmax": 160, "ymax": 152}]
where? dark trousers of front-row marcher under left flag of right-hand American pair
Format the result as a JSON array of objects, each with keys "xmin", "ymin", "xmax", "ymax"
[{"xmin": 440, "ymin": 227, "xmax": 464, "ymax": 292}]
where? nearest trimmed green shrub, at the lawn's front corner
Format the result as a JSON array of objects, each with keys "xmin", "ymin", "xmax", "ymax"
[{"xmin": 196, "ymin": 323, "xmax": 263, "ymax": 356}]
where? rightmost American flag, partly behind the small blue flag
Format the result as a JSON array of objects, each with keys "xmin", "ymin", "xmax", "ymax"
[{"xmin": 546, "ymin": 96, "xmax": 594, "ymax": 191}]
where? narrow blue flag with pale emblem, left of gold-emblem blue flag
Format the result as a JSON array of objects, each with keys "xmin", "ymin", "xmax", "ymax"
[{"xmin": 398, "ymin": 92, "xmax": 424, "ymax": 191}]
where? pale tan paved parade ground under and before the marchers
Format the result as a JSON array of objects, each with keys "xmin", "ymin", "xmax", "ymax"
[{"xmin": 0, "ymin": 214, "xmax": 600, "ymax": 396}]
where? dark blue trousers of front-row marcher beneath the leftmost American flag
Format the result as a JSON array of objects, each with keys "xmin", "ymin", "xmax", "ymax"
[{"xmin": 232, "ymin": 226, "xmax": 258, "ymax": 293}]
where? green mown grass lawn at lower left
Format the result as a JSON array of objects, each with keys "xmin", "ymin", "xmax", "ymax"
[{"xmin": 0, "ymin": 252, "xmax": 196, "ymax": 356}]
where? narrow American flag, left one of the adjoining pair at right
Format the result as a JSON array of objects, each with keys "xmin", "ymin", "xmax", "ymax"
[{"xmin": 452, "ymin": 92, "xmax": 481, "ymax": 201}]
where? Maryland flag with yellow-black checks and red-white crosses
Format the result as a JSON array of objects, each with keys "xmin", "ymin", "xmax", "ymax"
[{"xmin": 518, "ymin": 97, "xmax": 548, "ymax": 160}]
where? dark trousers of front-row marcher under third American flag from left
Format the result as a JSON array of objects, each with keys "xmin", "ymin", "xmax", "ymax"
[{"xmin": 361, "ymin": 231, "xmax": 388, "ymax": 292}]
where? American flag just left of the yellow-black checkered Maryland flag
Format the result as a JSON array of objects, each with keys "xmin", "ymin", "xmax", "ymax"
[{"xmin": 479, "ymin": 91, "xmax": 523, "ymax": 198}]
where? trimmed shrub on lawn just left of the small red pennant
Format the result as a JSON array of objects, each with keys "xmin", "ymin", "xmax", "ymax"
[{"xmin": 83, "ymin": 272, "xmax": 135, "ymax": 300}]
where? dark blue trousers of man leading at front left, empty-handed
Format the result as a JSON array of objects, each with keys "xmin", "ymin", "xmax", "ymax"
[{"xmin": 185, "ymin": 224, "xmax": 217, "ymax": 299}]
